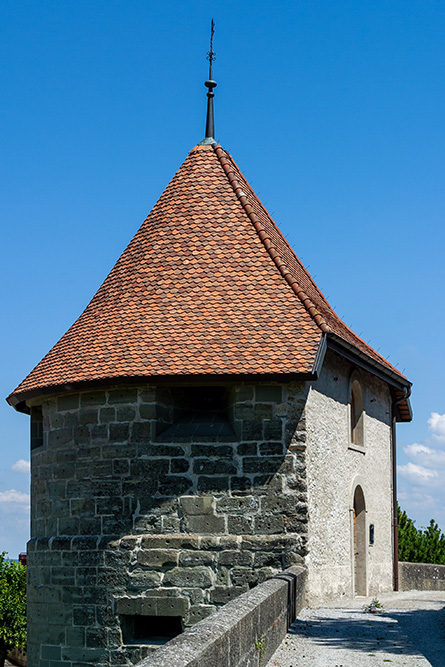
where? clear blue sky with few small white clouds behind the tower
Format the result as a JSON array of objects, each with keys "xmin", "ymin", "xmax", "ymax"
[{"xmin": 0, "ymin": 0, "xmax": 445, "ymax": 557}]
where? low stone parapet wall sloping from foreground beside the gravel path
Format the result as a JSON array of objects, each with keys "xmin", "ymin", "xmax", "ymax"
[{"xmin": 137, "ymin": 567, "xmax": 306, "ymax": 667}]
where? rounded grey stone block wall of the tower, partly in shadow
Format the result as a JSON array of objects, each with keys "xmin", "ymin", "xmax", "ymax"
[{"xmin": 28, "ymin": 384, "xmax": 307, "ymax": 667}]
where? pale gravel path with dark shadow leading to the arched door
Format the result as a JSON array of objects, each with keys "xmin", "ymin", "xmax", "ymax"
[{"xmin": 267, "ymin": 591, "xmax": 445, "ymax": 667}]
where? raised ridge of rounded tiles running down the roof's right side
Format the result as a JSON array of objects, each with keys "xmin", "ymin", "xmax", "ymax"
[{"xmin": 213, "ymin": 144, "xmax": 332, "ymax": 333}]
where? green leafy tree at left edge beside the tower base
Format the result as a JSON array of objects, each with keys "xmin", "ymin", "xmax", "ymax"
[{"xmin": 0, "ymin": 552, "xmax": 26, "ymax": 667}]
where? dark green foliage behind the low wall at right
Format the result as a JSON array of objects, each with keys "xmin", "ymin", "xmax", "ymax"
[{"xmin": 397, "ymin": 505, "xmax": 445, "ymax": 565}]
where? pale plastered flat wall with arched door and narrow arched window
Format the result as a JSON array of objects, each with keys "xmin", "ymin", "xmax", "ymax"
[{"xmin": 306, "ymin": 350, "xmax": 392, "ymax": 604}]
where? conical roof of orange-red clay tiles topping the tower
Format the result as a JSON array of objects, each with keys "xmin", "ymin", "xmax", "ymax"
[{"xmin": 8, "ymin": 145, "xmax": 410, "ymax": 405}]
